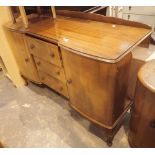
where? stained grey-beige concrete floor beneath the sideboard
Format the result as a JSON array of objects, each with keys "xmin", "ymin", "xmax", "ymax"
[{"xmin": 0, "ymin": 72, "xmax": 129, "ymax": 148}]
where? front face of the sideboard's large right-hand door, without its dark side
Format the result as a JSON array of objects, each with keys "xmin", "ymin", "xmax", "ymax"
[{"xmin": 62, "ymin": 49, "xmax": 116, "ymax": 128}]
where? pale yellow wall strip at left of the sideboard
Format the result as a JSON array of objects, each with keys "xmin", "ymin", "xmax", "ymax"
[{"xmin": 0, "ymin": 6, "xmax": 25, "ymax": 87}]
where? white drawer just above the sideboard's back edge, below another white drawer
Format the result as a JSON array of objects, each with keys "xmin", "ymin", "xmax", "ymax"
[{"xmin": 123, "ymin": 14, "xmax": 155, "ymax": 26}]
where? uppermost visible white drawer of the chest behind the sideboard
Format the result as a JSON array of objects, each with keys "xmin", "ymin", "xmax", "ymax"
[{"xmin": 123, "ymin": 6, "xmax": 155, "ymax": 15}]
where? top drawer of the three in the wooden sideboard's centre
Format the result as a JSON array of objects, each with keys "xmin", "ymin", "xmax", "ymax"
[{"xmin": 26, "ymin": 36, "xmax": 61, "ymax": 66}]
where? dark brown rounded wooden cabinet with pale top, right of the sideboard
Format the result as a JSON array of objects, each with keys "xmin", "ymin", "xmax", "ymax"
[{"xmin": 129, "ymin": 60, "xmax": 155, "ymax": 148}]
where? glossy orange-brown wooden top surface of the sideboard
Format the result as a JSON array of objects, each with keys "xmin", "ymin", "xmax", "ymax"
[{"xmin": 5, "ymin": 16, "xmax": 151, "ymax": 61}]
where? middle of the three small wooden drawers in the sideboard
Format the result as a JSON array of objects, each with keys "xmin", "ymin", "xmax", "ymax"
[{"xmin": 34, "ymin": 57, "xmax": 66, "ymax": 83}]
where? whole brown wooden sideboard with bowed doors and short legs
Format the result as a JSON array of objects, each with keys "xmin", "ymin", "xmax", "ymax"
[{"xmin": 6, "ymin": 11, "xmax": 151, "ymax": 146}]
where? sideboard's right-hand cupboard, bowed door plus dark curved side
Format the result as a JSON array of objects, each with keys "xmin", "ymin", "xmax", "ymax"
[{"xmin": 61, "ymin": 49, "xmax": 131, "ymax": 129}]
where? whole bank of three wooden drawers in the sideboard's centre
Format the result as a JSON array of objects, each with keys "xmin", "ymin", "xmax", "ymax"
[{"xmin": 26, "ymin": 36, "xmax": 68, "ymax": 98}]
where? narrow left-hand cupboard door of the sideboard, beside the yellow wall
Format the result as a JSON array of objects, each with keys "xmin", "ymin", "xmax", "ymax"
[{"xmin": 9, "ymin": 31, "xmax": 40, "ymax": 83}]
